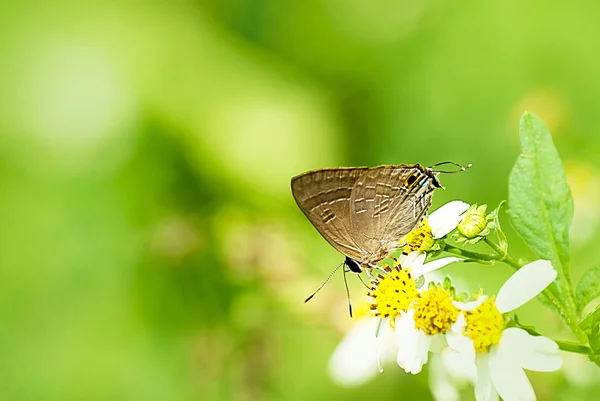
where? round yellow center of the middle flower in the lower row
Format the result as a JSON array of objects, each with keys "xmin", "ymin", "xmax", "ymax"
[{"xmin": 414, "ymin": 285, "xmax": 459, "ymax": 336}]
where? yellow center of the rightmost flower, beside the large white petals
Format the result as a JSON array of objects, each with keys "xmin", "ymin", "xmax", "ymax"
[{"xmin": 464, "ymin": 297, "xmax": 504, "ymax": 352}]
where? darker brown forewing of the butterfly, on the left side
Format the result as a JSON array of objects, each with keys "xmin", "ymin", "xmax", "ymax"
[{"xmin": 292, "ymin": 167, "xmax": 368, "ymax": 260}]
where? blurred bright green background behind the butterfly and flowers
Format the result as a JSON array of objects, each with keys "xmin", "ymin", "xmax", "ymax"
[{"xmin": 0, "ymin": 0, "xmax": 600, "ymax": 401}]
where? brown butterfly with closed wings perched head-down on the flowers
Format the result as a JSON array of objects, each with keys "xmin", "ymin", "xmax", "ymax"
[{"xmin": 292, "ymin": 164, "xmax": 450, "ymax": 273}]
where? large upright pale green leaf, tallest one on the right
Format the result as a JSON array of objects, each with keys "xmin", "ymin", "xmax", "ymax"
[{"xmin": 508, "ymin": 113, "xmax": 573, "ymax": 285}]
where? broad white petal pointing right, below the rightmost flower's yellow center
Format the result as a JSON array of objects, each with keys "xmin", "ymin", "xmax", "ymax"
[{"xmin": 500, "ymin": 327, "xmax": 562, "ymax": 372}]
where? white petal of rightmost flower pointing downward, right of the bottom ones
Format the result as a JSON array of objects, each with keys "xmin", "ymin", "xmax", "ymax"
[{"xmin": 489, "ymin": 344, "xmax": 535, "ymax": 401}]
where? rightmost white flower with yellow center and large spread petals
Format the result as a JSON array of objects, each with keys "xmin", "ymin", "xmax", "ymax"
[{"xmin": 446, "ymin": 260, "xmax": 562, "ymax": 401}]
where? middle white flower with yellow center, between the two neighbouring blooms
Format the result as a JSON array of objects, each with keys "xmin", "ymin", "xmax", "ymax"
[{"xmin": 395, "ymin": 254, "xmax": 461, "ymax": 374}]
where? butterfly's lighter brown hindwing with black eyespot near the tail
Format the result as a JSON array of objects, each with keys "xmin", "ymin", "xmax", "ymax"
[{"xmin": 350, "ymin": 164, "xmax": 434, "ymax": 252}]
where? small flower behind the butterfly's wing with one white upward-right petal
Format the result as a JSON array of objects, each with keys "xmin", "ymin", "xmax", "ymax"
[{"xmin": 400, "ymin": 200, "xmax": 469, "ymax": 264}]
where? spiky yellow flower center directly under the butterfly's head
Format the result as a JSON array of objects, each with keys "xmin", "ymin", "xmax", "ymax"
[{"xmin": 367, "ymin": 263, "xmax": 419, "ymax": 324}]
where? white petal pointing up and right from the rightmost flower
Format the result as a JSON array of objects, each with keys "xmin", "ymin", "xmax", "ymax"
[{"xmin": 496, "ymin": 260, "xmax": 557, "ymax": 313}]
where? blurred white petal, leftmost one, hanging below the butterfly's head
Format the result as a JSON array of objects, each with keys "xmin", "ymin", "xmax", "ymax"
[{"xmin": 329, "ymin": 316, "xmax": 396, "ymax": 387}]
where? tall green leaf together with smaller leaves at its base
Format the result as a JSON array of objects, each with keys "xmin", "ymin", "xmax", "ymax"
[{"xmin": 509, "ymin": 113, "xmax": 600, "ymax": 356}]
